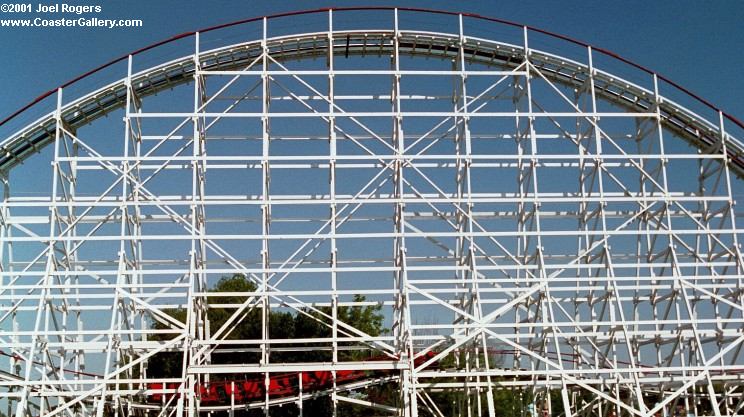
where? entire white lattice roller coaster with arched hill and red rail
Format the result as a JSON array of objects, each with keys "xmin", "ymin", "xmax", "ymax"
[{"xmin": 0, "ymin": 7, "xmax": 744, "ymax": 417}]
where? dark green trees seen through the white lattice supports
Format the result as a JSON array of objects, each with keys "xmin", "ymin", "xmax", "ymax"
[{"xmin": 147, "ymin": 274, "xmax": 561, "ymax": 417}]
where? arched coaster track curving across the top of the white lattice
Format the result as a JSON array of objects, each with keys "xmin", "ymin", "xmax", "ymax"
[{"xmin": 0, "ymin": 8, "xmax": 744, "ymax": 176}]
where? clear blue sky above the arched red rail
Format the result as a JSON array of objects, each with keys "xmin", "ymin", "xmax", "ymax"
[{"xmin": 0, "ymin": 0, "xmax": 744, "ymax": 127}]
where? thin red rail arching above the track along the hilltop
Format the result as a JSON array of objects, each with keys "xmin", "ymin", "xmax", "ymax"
[{"xmin": 0, "ymin": 6, "xmax": 744, "ymax": 133}]
